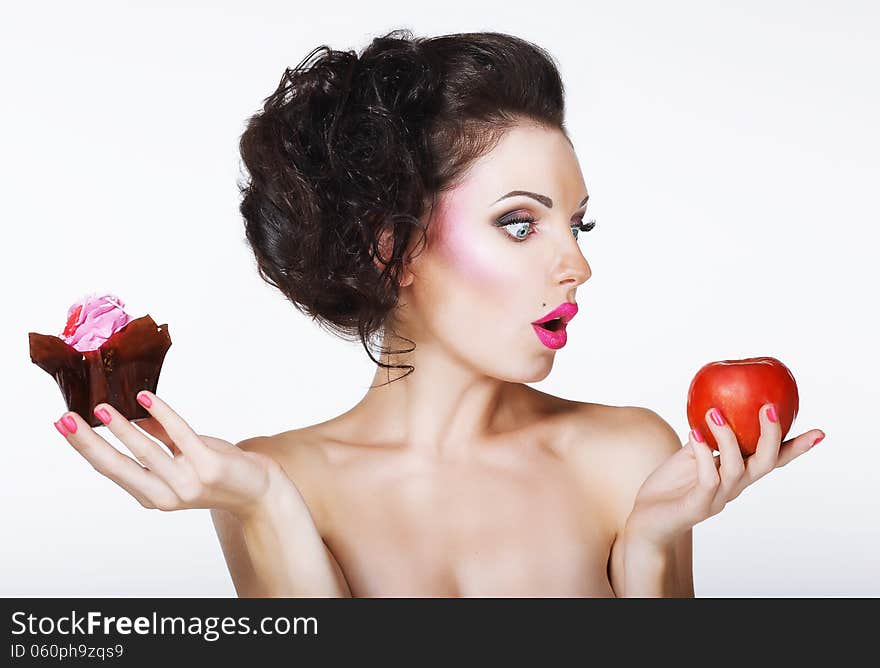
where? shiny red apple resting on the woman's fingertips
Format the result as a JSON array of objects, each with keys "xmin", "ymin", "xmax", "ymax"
[{"xmin": 687, "ymin": 357, "xmax": 798, "ymax": 456}]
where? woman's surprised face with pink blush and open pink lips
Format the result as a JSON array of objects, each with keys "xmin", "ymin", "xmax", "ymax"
[{"xmin": 398, "ymin": 120, "xmax": 591, "ymax": 382}]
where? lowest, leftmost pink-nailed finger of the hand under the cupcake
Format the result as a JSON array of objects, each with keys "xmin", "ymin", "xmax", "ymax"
[{"xmin": 57, "ymin": 412, "xmax": 176, "ymax": 508}]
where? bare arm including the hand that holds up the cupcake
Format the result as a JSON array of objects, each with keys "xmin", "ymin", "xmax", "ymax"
[{"xmin": 56, "ymin": 390, "xmax": 351, "ymax": 597}]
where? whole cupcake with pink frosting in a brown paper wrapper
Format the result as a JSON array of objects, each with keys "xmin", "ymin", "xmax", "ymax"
[{"xmin": 28, "ymin": 294, "xmax": 171, "ymax": 427}]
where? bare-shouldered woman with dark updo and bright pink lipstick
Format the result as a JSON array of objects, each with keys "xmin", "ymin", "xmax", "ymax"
[{"xmin": 53, "ymin": 31, "xmax": 819, "ymax": 596}]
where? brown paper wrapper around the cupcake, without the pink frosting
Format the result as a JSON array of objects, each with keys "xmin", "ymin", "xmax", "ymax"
[{"xmin": 28, "ymin": 315, "xmax": 171, "ymax": 427}]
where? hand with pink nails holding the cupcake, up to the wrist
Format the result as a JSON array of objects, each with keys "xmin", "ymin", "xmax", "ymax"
[{"xmin": 56, "ymin": 391, "xmax": 293, "ymax": 521}]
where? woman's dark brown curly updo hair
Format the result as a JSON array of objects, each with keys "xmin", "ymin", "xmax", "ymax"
[{"xmin": 238, "ymin": 29, "xmax": 568, "ymax": 384}]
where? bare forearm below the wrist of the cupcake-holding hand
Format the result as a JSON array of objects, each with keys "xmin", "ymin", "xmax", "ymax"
[{"xmin": 211, "ymin": 439, "xmax": 351, "ymax": 598}]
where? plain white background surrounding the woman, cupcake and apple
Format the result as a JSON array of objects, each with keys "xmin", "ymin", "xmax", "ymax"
[{"xmin": 0, "ymin": 0, "xmax": 880, "ymax": 596}]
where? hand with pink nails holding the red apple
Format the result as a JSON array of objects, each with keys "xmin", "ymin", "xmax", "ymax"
[{"xmin": 626, "ymin": 404, "xmax": 824, "ymax": 548}]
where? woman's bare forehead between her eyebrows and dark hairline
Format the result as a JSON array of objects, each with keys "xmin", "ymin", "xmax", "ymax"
[{"xmin": 455, "ymin": 125, "xmax": 587, "ymax": 208}]
